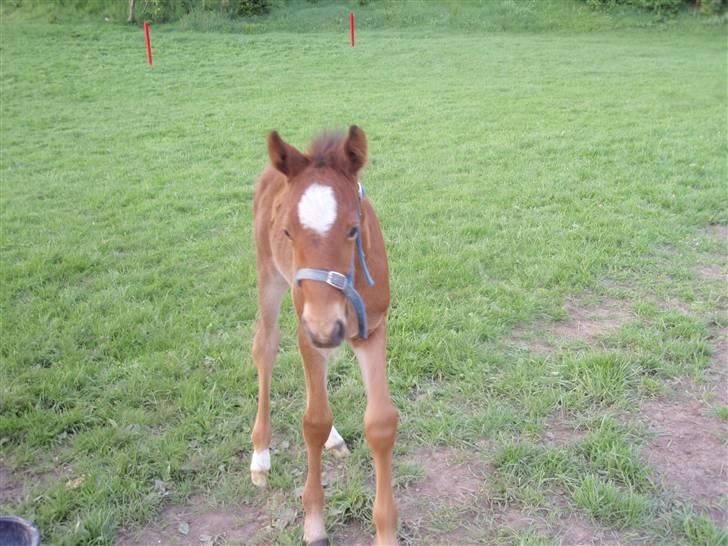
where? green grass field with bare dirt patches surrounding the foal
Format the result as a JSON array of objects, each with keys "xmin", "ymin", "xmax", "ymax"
[{"xmin": 0, "ymin": 3, "xmax": 728, "ymax": 545}]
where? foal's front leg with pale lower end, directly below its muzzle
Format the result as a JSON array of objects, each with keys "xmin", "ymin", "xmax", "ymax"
[{"xmin": 298, "ymin": 327, "xmax": 334, "ymax": 545}]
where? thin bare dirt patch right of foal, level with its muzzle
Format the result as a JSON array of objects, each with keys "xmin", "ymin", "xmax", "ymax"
[{"xmin": 513, "ymin": 298, "xmax": 633, "ymax": 353}]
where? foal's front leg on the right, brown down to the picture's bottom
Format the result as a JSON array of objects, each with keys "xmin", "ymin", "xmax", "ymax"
[{"xmin": 352, "ymin": 323, "xmax": 399, "ymax": 545}]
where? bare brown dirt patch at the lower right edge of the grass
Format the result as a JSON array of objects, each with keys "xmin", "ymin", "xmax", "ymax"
[{"xmin": 641, "ymin": 383, "xmax": 728, "ymax": 525}]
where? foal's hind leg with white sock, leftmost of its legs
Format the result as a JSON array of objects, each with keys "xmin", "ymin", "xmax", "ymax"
[{"xmin": 250, "ymin": 271, "xmax": 288, "ymax": 487}]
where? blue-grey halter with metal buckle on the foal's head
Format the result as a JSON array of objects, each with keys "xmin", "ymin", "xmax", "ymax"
[{"xmin": 296, "ymin": 183, "xmax": 374, "ymax": 339}]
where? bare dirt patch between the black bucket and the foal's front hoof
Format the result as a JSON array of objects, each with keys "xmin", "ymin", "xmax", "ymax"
[{"xmin": 118, "ymin": 497, "xmax": 270, "ymax": 546}]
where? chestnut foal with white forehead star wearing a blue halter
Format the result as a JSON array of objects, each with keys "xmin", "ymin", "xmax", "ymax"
[{"xmin": 250, "ymin": 125, "xmax": 399, "ymax": 546}]
